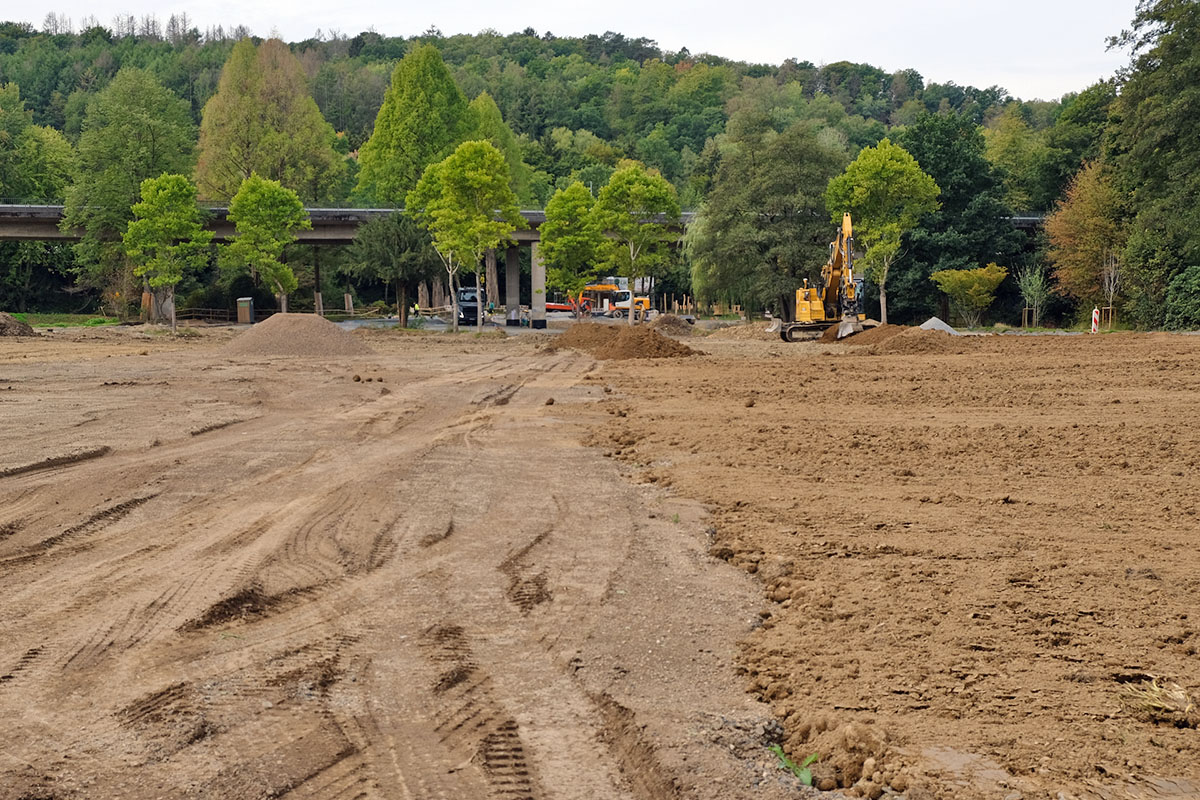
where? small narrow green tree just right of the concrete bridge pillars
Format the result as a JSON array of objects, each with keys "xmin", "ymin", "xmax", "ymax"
[{"xmin": 538, "ymin": 181, "xmax": 604, "ymax": 315}]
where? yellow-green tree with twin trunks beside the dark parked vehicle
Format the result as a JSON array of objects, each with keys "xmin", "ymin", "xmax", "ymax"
[{"xmin": 406, "ymin": 142, "xmax": 526, "ymax": 331}]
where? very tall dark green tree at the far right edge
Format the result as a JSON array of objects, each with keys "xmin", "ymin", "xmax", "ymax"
[{"xmin": 1106, "ymin": 0, "xmax": 1200, "ymax": 326}]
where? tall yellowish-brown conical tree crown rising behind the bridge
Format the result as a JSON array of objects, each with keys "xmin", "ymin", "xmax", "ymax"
[{"xmin": 196, "ymin": 38, "xmax": 346, "ymax": 203}]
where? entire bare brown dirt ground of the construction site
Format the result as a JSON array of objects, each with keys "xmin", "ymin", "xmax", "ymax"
[{"xmin": 0, "ymin": 329, "xmax": 1200, "ymax": 800}]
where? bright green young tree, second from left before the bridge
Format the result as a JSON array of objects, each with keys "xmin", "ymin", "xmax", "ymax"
[{"xmin": 221, "ymin": 174, "xmax": 312, "ymax": 313}]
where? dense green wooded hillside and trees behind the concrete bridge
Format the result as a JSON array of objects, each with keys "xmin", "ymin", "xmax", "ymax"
[{"xmin": 0, "ymin": 0, "xmax": 1200, "ymax": 327}]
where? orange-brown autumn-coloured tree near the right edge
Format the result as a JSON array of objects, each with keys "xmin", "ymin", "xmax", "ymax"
[{"xmin": 1045, "ymin": 162, "xmax": 1126, "ymax": 306}]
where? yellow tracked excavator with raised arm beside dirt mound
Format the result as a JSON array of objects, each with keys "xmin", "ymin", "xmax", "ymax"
[{"xmin": 768, "ymin": 213, "xmax": 866, "ymax": 342}]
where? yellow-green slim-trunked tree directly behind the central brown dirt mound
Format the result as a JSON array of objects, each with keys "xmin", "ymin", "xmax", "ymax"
[{"xmin": 593, "ymin": 162, "xmax": 679, "ymax": 325}]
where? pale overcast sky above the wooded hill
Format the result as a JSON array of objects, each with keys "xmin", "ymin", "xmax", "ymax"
[{"xmin": 25, "ymin": 0, "xmax": 1135, "ymax": 100}]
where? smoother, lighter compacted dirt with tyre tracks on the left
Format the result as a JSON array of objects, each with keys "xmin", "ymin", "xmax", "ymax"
[{"xmin": 0, "ymin": 332, "xmax": 796, "ymax": 799}]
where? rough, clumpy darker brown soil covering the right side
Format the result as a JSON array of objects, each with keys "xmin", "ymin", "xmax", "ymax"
[{"xmin": 571, "ymin": 331, "xmax": 1200, "ymax": 800}]
